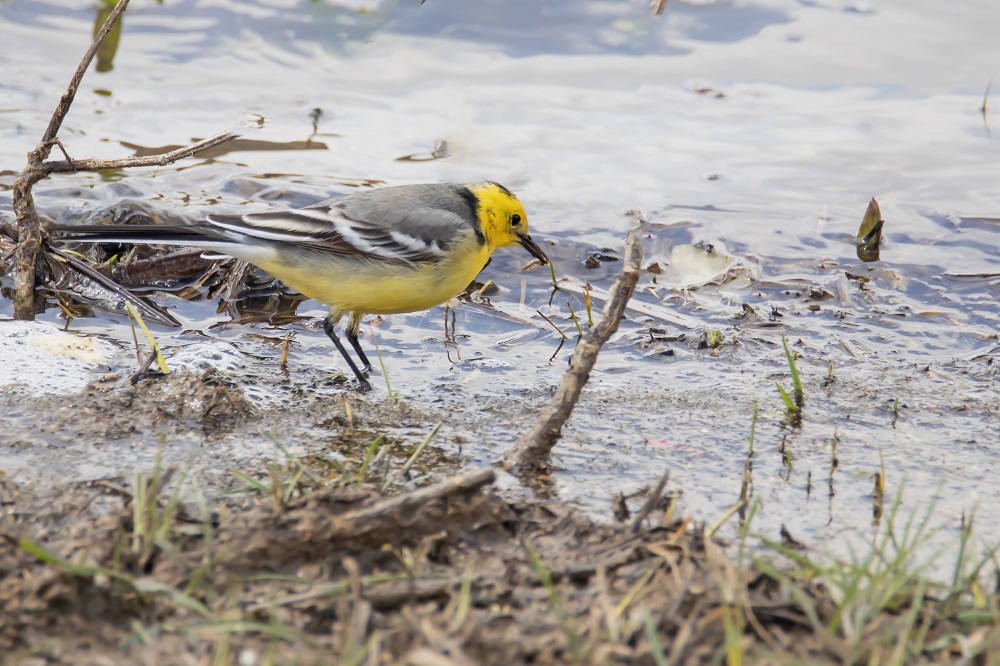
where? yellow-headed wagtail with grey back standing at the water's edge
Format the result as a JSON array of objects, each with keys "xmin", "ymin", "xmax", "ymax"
[{"xmin": 51, "ymin": 181, "xmax": 549, "ymax": 392}]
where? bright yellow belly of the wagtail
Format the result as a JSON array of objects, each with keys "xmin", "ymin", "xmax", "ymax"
[{"xmin": 255, "ymin": 247, "xmax": 490, "ymax": 314}]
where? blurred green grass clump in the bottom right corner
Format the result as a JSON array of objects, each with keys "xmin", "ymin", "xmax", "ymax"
[{"xmin": 754, "ymin": 486, "xmax": 1000, "ymax": 664}]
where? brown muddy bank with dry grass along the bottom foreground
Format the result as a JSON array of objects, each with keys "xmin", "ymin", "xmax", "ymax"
[{"xmin": 0, "ymin": 456, "xmax": 1000, "ymax": 664}]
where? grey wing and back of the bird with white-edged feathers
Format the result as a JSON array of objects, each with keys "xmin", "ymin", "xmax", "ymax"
[{"xmin": 208, "ymin": 185, "xmax": 479, "ymax": 262}]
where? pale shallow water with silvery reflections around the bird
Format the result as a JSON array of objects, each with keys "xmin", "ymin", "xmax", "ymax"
[{"xmin": 0, "ymin": 0, "xmax": 1000, "ymax": 564}]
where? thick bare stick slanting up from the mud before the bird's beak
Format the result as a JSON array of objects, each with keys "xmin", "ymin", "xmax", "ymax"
[{"xmin": 503, "ymin": 227, "xmax": 642, "ymax": 471}]
